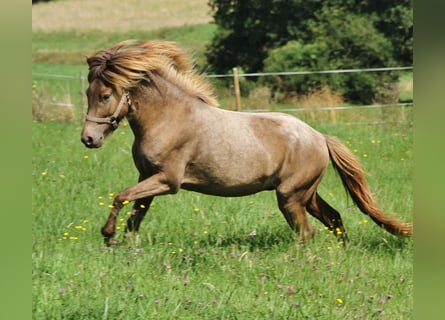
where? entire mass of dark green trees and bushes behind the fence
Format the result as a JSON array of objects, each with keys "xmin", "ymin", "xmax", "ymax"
[{"xmin": 207, "ymin": 0, "xmax": 413, "ymax": 104}]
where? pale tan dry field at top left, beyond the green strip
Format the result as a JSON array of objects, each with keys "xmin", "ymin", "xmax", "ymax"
[{"xmin": 32, "ymin": 0, "xmax": 212, "ymax": 32}]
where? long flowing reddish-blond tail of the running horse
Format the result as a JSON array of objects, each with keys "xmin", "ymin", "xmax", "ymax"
[{"xmin": 325, "ymin": 136, "xmax": 413, "ymax": 236}]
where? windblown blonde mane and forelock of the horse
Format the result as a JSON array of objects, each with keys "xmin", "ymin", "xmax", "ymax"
[{"xmin": 87, "ymin": 40, "xmax": 218, "ymax": 106}]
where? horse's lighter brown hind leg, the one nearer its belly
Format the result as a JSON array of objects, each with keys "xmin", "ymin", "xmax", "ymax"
[{"xmin": 277, "ymin": 191, "xmax": 314, "ymax": 241}]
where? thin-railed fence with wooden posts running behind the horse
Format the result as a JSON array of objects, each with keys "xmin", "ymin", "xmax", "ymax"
[{"xmin": 32, "ymin": 66, "xmax": 413, "ymax": 119}]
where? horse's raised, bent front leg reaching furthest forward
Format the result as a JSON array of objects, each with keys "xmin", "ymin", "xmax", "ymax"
[{"xmin": 101, "ymin": 172, "xmax": 179, "ymax": 245}]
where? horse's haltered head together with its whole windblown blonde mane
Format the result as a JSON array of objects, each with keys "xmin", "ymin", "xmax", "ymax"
[{"xmin": 82, "ymin": 40, "xmax": 218, "ymax": 148}]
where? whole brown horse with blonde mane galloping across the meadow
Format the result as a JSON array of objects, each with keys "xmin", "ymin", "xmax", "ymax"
[{"xmin": 81, "ymin": 40, "xmax": 413, "ymax": 244}]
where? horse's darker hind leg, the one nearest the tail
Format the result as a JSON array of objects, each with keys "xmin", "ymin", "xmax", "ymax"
[{"xmin": 306, "ymin": 192, "xmax": 348, "ymax": 242}]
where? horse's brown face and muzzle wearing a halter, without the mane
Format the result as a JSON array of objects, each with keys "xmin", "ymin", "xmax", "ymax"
[{"xmin": 81, "ymin": 79, "xmax": 130, "ymax": 148}]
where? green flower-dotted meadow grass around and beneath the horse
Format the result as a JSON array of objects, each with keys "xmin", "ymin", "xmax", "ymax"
[{"xmin": 32, "ymin": 114, "xmax": 413, "ymax": 320}]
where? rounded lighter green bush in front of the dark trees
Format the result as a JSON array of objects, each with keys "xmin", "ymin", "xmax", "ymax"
[{"xmin": 309, "ymin": 7, "xmax": 397, "ymax": 104}]
